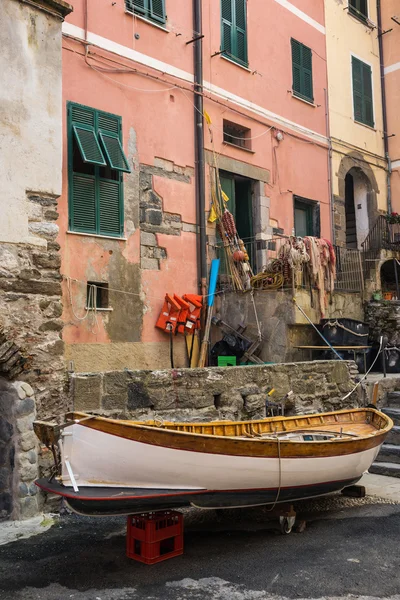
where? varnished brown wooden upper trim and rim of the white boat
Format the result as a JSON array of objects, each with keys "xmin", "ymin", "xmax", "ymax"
[{"xmin": 59, "ymin": 409, "xmax": 393, "ymax": 458}]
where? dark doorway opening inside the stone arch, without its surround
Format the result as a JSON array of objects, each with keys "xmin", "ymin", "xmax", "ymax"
[{"xmin": 344, "ymin": 167, "xmax": 370, "ymax": 248}]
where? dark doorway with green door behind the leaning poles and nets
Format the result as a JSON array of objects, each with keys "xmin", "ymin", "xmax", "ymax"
[{"xmin": 219, "ymin": 171, "xmax": 256, "ymax": 273}]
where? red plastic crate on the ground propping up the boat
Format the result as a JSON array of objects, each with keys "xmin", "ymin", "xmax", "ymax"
[{"xmin": 126, "ymin": 510, "xmax": 183, "ymax": 565}]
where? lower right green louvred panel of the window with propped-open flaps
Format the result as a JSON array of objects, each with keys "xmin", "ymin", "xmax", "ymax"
[{"xmin": 98, "ymin": 179, "xmax": 122, "ymax": 236}]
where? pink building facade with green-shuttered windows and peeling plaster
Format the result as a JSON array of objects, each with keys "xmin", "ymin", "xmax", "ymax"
[{"xmin": 58, "ymin": 0, "xmax": 332, "ymax": 372}]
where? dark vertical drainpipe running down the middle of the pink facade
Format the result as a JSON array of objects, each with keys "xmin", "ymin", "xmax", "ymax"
[{"xmin": 193, "ymin": 0, "xmax": 207, "ymax": 296}]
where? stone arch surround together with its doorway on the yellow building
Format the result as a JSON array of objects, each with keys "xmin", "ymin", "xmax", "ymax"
[{"xmin": 334, "ymin": 151, "xmax": 379, "ymax": 248}]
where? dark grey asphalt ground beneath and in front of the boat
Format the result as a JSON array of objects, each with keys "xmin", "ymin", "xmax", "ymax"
[{"xmin": 0, "ymin": 505, "xmax": 400, "ymax": 600}]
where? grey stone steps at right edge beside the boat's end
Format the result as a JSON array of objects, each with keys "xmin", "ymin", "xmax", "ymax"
[{"xmin": 369, "ymin": 392, "xmax": 400, "ymax": 477}]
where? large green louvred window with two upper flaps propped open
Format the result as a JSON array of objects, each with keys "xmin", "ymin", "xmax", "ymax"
[{"xmin": 67, "ymin": 102, "xmax": 130, "ymax": 237}]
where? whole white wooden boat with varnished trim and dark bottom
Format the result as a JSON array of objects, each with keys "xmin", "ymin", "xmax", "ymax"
[{"xmin": 34, "ymin": 408, "xmax": 393, "ymax": 514}]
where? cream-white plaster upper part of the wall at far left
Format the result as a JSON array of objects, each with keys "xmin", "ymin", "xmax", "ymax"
[{"xmin": 0, "ymin": 0, "xmax": 62, "ymax": 245}]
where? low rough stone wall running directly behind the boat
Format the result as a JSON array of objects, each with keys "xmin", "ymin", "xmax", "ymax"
[{"xmin": 70, "ymin": 361, "xmax": 358, "ymax": 421}]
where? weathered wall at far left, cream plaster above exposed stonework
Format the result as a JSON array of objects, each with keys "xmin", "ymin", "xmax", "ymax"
[{"xmin": 0, "ymin": 0, "xmax": 71, "ymax": 518}]
